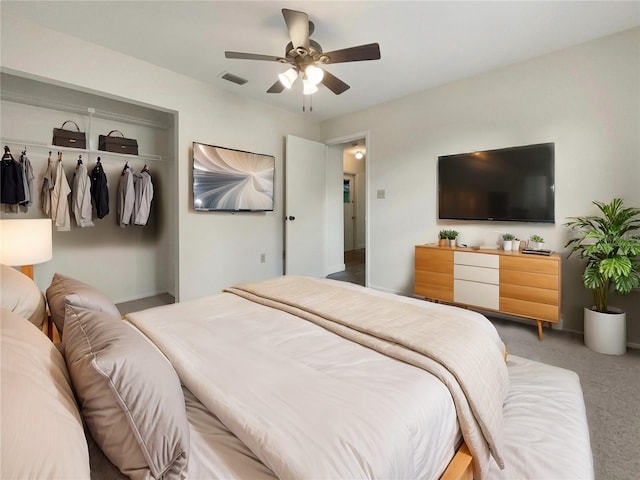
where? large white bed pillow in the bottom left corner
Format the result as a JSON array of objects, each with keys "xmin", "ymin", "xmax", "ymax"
[{"xmin": 0, "ymin": 310, "xmax": 90, "ymax": 479}]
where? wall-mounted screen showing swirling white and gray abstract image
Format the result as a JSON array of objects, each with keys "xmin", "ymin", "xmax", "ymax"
[{"xmin": 193, "ymin": 142, "xmax": 275, "ymax": 212}]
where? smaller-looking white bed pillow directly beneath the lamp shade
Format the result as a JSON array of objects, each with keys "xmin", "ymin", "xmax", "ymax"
[{"xmin": 0, "ymin": 264, "xmax": 46, "ymax": 328}]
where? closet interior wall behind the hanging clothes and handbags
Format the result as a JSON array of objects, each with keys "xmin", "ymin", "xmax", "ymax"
[{"xmin": 0, "ymin": 73, "xmax": 176, "ymax": 302}]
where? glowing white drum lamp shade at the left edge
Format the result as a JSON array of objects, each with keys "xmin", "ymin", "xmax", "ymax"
[{"xmin": 0, "ymin": 218, "xmax": 53, "ymax": 266}]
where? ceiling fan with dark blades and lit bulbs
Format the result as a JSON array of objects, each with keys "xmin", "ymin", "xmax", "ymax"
[{"xmin": 224, "ymin": 8, "xmax": 380, "ymax": 95}]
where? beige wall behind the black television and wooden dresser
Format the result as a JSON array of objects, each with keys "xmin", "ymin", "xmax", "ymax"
[{"xmin": 321, "ymin": 28, "xmax": 640, "ymax": 344}]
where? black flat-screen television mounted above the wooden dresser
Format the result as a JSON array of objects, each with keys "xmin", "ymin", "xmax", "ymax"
[{"xmin": 438, "ymin": 143, "xmax": 555, "ymax": 223}]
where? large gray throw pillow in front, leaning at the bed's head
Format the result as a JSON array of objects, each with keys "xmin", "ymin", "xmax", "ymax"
[{"xmin": 63, "ymin": 302, "xmax": 189, "ymax": 479}]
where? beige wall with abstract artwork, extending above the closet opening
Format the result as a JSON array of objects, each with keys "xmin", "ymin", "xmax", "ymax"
[{"xmin": 0, "ymin": 14, "xmax": 319, "ymax": 301}]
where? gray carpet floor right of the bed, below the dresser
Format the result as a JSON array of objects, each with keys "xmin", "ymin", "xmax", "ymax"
[{"xmin": 490, "ymin": 318, "xmax": 640, "ymax": 480}]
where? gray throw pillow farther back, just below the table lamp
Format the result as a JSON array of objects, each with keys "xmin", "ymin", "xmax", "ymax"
[{"xmin": 47, "ymin": 273, "xmax": 120, "ymax": 335}]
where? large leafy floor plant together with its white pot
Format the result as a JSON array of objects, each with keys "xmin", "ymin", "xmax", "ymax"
[{"xmin": 564, "ymin": 198, "xmax": 640, "ymax": 355}]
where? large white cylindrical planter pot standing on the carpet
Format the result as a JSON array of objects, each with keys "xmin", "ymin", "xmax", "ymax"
[{"xmin": 584, "ymin": 307, "xmax": 627, "ymax": 355}]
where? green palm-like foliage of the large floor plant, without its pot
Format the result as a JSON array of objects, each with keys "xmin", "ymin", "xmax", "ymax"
[{"xmin": 564, "ymin": 198, "xmax": 640, "ymax": 313}]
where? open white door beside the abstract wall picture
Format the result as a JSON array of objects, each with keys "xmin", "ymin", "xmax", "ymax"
[{"xmin": 284, "ymin": 135, "xmax": 326, "ymax": 277}]
